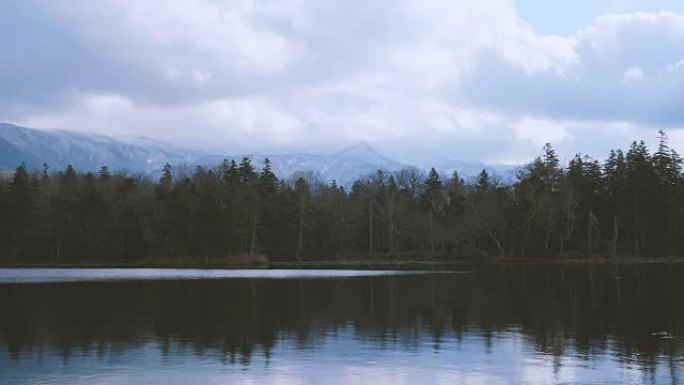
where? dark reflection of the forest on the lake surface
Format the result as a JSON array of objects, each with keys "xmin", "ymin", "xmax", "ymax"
[{"xmin": 0, "ymin": 265, "xmax": 684, "ymax": 373}]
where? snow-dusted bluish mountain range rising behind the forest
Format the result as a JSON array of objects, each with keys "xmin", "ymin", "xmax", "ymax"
[{"xmin": 0, "ymin": 123, "xmax": 512, "ymax": 185}]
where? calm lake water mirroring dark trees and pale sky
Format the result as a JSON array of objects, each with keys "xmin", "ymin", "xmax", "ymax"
[{"xmin": 0, "ymin": 265, "xmax": 684, "ymax": 385}]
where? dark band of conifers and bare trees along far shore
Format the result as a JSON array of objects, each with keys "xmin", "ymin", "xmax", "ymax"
[{"xmin": 0, "ymin": 131, "xmax": 684, "ymax": 264}]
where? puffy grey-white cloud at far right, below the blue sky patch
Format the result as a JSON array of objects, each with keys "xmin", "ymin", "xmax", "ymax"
[{"xmin": 466, "ymin": 12, "xmax": 684, "ymax": 128}]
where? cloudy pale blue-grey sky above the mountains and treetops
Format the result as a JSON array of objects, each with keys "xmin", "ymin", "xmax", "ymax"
[{"xmin": 0, "ymin": 0, "xmax": 684, "ymax": 164}]
